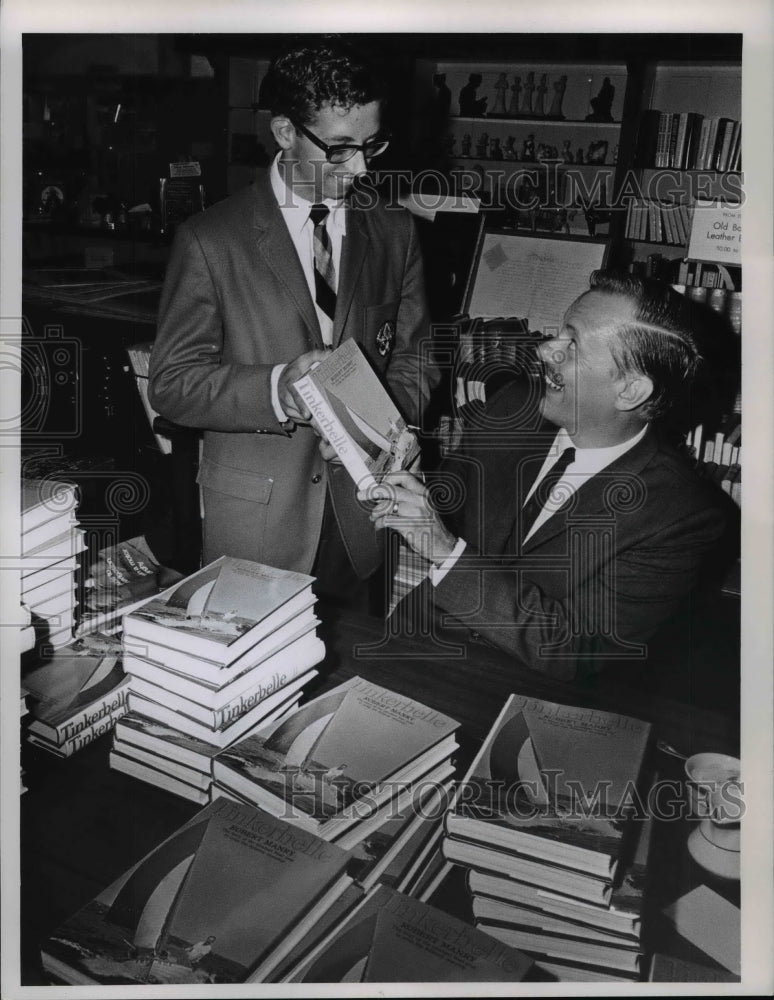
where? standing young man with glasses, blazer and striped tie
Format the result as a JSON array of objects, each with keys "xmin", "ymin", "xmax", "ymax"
[{"xmin": 150, "ymin": 37, "xmax": 437, "ymax": 600}]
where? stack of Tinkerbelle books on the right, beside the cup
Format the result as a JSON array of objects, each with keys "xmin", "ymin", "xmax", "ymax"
[{"xmin": 443, "ymin": 695, "xmax": 650, "ymax": 982}]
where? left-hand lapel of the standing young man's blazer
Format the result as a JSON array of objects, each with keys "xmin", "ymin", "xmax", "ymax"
[{"xmin": 253, "ymin": 178, "xmax": 324, "ymax": 349}]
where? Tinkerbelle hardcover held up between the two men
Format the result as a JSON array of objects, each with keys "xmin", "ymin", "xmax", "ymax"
[{"xmin": 294, "ymin": 340, "xmax": 419, "ymax": 489}]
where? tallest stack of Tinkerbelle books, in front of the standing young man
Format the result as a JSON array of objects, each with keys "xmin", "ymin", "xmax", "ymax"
[{"xmin": 110, "ymin": 556, "xmax": 325, "ymax": 803}]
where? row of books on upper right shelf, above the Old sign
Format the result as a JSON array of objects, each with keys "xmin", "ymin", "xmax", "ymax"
[{"xmin": 637, "ymin": 108, "xmax": 742, "ymax": 171}]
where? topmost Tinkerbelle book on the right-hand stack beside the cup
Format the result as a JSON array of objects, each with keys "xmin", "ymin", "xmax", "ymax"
[{"xmin": 447, "ymin": 694, "xmax": 650, "ymax": 879}]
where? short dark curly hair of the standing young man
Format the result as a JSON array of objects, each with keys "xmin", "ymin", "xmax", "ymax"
[{"xmin": 261, "ymin": 36, "xmax": 386, "ymax": 125}]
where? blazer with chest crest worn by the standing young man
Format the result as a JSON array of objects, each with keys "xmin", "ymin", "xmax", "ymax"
[{"xmin": 150, "ymin": 171, "xmax": 437, "ymax": 577}]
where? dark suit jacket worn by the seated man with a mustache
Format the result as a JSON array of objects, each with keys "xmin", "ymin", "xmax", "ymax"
[{"xmin": 424, "ymin": 386, "xmax": 726, "ymax": 678}]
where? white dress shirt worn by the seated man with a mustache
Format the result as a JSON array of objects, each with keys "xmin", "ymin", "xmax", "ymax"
[{"xmin": 430, "ymin": 424, "xmax": 648, "ymax": 586}]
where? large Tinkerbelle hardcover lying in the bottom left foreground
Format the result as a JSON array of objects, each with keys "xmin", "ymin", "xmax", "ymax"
[{"xmin": 41, "ymin": 798, "xmax": 351, "ymax": 986}]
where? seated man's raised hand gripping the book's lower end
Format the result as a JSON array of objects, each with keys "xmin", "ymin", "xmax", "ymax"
[{"xmin": 358, "ymin": 472, "xmax": 457, "ymax": 566}]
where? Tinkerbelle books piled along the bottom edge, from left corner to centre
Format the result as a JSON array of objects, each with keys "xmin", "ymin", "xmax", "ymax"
[{"xmin": 41, "ymin": 797, "xmax": 532, "ymax": 986}]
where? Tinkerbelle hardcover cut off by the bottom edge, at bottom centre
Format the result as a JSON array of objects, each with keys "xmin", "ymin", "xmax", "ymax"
[{"xmin": 289, "ymin": 885, "xmax": 533, "ymax": 983}]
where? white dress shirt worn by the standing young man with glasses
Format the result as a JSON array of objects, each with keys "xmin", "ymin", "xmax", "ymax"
[{"xmin": 269, "ymin": 153, "xmax": 347, "ymax": 423}]
